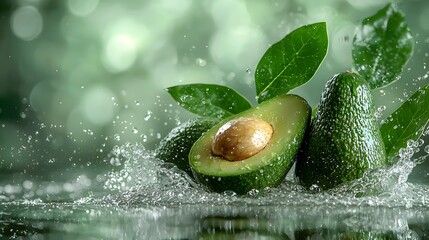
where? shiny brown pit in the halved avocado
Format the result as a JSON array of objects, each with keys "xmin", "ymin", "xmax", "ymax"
[{"xmin": 211, "ymin": 117, "xmax": 274, "ymax": 161}]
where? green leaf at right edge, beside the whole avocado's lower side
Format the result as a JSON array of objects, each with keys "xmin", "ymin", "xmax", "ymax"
[{"xmin": 381, "ymin": 84, "xmax": 429, "ymax": 160}]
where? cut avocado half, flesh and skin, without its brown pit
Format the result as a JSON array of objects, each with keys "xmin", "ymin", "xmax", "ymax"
[{"xmin": 189, "ymin": 95, "xmax": 311, "ymax": 194}]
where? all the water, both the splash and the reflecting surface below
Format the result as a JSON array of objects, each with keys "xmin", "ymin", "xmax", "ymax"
[{"xmin": 0, "ymin": 131, "xmax": 429, "ymax": 239}]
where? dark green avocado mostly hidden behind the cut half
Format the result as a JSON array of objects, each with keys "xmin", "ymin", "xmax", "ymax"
[{"xmin": 155, "ymin": 118, "xmax": 219, "ymax": 176}]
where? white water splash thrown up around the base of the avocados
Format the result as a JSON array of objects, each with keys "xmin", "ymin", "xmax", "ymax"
[{"xmin": 92, "ymin": 133, "xmax": 429, "ymax": 208}]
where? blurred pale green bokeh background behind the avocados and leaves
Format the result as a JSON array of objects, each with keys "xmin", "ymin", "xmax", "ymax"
[{"xmin": 0, "ymin": 0, "xmax": 429, "ymax": 187}]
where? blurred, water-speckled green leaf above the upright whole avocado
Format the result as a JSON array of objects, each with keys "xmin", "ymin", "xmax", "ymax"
[{"xmin": 352, "ymin": 4, "xmax": 413, "ymax": 89}]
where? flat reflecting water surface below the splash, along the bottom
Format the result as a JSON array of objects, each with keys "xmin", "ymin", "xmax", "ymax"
[{"xmin": 0, "ymin": 203, "xmax": 429, "ymax": 239}]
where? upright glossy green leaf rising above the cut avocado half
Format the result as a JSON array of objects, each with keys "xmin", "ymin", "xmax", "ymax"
[{"xmin": 255, "ymin": 22, "xmax": 328, "ymax": 102}]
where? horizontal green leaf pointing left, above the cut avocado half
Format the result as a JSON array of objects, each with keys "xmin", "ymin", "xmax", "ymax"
[{"xmin": 166, "ymin": 84, "xmax": 252, "ymax": 119}]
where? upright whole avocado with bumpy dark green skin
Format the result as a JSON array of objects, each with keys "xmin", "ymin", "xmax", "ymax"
[{"xmin": 295, "ymin": 71, "xmax": 386, "ymax": 189}]
